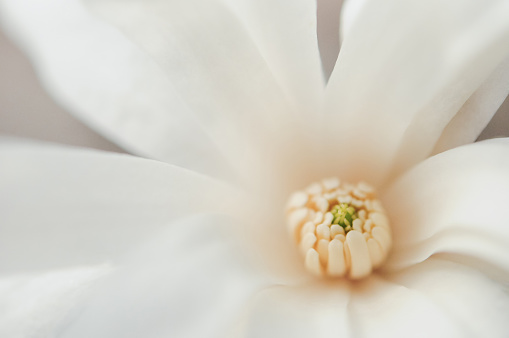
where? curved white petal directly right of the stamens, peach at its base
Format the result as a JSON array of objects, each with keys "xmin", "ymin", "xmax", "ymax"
[{"xmin": 383, "ymin": 139, "xmax": 509, "ymax": 278}]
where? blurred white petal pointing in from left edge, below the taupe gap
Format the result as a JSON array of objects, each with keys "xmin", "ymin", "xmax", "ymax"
[{"xmin": 0, "ymin": 142, "xmax": 236, "ymax": 272}]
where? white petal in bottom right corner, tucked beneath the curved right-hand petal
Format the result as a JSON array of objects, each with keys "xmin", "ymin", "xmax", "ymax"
[{"xmin": 386, "ymin": 258, "xmax": 509, "ymax": 338}]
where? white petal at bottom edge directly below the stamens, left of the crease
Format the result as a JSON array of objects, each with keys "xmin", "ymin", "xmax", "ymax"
[{"xmin": 241, "ymin": 283, "xmax": 352, "ymax": 338}]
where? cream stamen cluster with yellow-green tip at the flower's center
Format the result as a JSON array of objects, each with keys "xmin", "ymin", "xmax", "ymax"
[{"xmin": 286, "ymin": 178, "xmax": 392, "ymax": 279}]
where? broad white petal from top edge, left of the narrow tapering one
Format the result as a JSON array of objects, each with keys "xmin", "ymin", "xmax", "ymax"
[{"xmin": 88, "ymin": 0, "xmax": 304, "ymax": 186}]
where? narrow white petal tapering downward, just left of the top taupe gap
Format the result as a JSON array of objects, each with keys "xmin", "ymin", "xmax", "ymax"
[{"xmin": 225, "ymin": 0, "xmax": 325, "ymax": 113}]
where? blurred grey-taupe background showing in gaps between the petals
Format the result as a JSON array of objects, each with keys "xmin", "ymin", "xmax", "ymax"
[{"xmin": 0, "ymin": 0, "xmax": 509, "ymax": 152}]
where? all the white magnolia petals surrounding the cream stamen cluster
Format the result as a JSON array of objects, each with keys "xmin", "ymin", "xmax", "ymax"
[{"xmin": 0, "ymin": 0, "xmax": 509, "ymax": 338}]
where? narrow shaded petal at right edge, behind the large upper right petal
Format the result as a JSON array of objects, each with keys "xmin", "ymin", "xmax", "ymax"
[{"xmin": 433, "ymin": 59, "xmax": 509, "ymax": 153}]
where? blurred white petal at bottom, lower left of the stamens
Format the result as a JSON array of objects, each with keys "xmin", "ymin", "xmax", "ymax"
[{"xmin": 62, "ymin": 214, "xmax": 267, "ymax": 338}]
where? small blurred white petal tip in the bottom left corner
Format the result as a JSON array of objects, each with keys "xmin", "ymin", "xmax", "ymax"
[{"xmin": 0, "ymin": 265, "xmax": 109, "ymax": 338}]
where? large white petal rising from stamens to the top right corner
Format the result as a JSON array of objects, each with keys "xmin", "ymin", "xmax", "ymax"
[{"xmin": 324, "ymin": 0, "xmax": 509, "ymax": 183}]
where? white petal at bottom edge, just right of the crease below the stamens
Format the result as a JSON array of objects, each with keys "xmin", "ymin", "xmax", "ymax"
[{"xmin": 349, "ymin": 275, "xmax": 466, "ymax": 338}]
